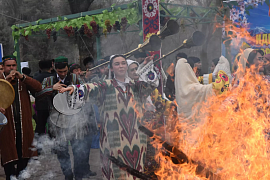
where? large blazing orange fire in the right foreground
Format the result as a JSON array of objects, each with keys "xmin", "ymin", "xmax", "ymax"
[{"xmin": 147, "ymin": 20, "xmax": 270, "ymax": 180}]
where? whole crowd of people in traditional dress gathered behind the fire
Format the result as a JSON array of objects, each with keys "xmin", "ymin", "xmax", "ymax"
[{"xmin": 0, "ymin": 48, "xmax": 270, "ymax": 180}]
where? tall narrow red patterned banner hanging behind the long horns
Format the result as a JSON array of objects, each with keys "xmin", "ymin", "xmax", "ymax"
[{"xmin": 142, "ymin": 0, "xmax": 163, "ymax": 95}]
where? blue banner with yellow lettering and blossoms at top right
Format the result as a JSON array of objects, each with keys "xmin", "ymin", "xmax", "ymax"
[{"xmin": 225, "ymin": 0, "xmax": 270, "ymax": 62}]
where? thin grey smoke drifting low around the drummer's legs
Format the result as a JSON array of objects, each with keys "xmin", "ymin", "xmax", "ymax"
[{"xmin": 12, "ymin": 99, "xmax": 98, "ymax": 180}]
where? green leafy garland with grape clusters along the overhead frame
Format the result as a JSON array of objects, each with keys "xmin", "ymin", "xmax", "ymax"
[{"xmin": 11, "ymin": 2, "xmax": 141, "ymax": 56}]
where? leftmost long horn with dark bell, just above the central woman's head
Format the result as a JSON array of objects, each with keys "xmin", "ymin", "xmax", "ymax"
[{"xmin": 124, "ymin": 35, "xmax": 161, "ymax": 58}]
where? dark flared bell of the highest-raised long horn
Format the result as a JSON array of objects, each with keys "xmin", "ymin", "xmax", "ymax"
[{"xmin": 157, "ymin": 20, "xmax": 180, "ymax": 39}]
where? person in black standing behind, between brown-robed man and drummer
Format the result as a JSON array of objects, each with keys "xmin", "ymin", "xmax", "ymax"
[{"xmin": 34, "ymin": 60, "xmax": 53, "ymax": 135}]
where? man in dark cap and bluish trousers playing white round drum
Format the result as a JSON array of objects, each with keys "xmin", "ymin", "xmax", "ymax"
[{"xmin": 36, "ymin": 56, "xmax": 96, "ymax": 180}]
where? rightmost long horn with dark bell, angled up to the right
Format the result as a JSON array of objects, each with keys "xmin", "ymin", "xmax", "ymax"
[{"xmin": 154, "ymin": 31, "xmax": 205, "ymax": 63}]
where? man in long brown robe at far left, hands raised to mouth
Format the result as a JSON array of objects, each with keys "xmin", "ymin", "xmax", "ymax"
[{"xmin": 0, "ymin": 56, "xmax": 42, "ymax": 180}]
